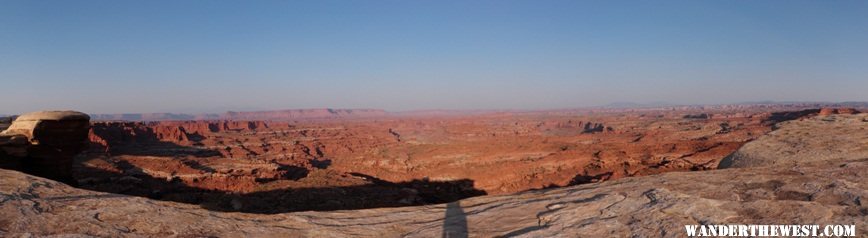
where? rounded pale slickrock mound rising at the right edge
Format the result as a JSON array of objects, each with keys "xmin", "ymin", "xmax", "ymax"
[{"xmin": 719, "ymin": 110, "xmax": 868, "ymax": 168}]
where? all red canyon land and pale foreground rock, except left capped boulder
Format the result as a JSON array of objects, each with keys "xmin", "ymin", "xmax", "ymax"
[{"xmin": 0, "ymin": 104, "xmax": 868, "ymax": 237}]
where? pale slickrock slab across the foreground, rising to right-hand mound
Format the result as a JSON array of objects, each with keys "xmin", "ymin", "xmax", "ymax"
[{"xmin": 0, "ymin": 114, "xmax": 868, "ymax": 237}]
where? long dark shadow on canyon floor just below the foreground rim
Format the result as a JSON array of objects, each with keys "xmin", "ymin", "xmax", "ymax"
[{"xmin": 71, "ymin": 161, "xmax": 486, "ymax": 214}]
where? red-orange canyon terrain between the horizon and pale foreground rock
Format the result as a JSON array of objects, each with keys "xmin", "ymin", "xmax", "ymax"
[{"xmin": 73, "ymin": 106, "xmax": 848, "ymax": 213}]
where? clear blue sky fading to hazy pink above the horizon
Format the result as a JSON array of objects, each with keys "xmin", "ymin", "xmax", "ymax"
[{"xmin": 0, "ymin": 0, "xmax": 868, "ymax": 113}]
